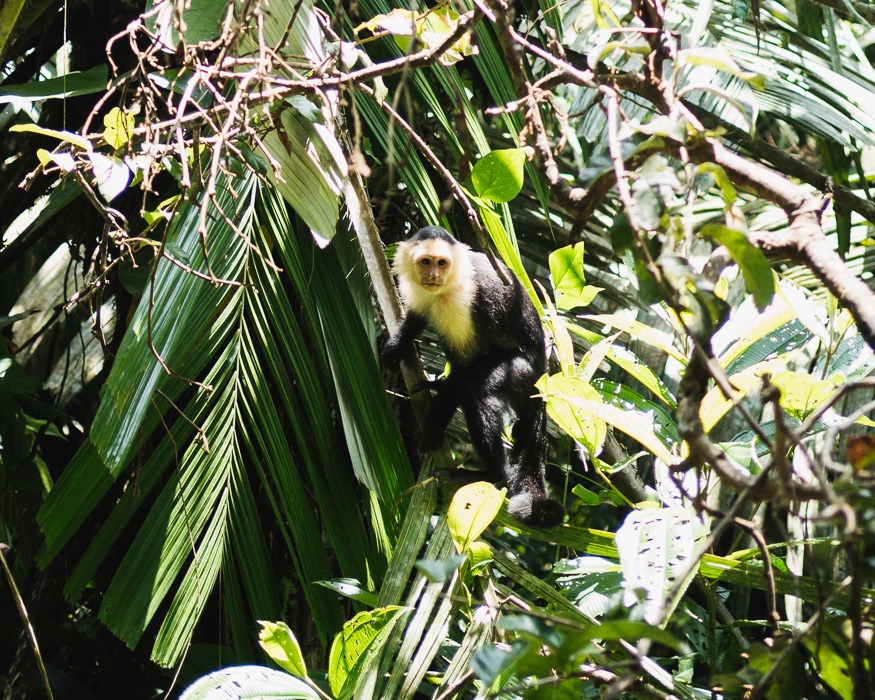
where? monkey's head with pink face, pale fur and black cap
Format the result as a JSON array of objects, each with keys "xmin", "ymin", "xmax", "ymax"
[{"xmin": 394, "ymin": 226, "xmax": 467, "ymax": 294}]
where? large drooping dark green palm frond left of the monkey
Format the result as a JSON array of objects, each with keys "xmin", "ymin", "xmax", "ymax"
[{"xmin": 41, "ymin": 168, "xmax": 418, "ymax": 664}]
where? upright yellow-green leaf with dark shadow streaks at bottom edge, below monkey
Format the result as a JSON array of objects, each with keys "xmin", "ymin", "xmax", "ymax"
[{"xmin": 328, "ymin": 605, "xmax": 404, "ymax": 700}]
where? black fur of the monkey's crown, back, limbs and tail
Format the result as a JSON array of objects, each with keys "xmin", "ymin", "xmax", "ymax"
[{"xmin": 383, "ymin": 226, "xmax": 564, "ymax": 527}]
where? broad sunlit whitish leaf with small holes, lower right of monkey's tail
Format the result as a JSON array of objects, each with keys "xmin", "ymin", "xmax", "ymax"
[{"xmin": 615, "ymin": 508, "xmax": 699, "ymax": 625}]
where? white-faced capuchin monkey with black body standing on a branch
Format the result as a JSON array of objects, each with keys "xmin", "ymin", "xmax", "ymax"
[{"xmin": 382, "ymin": 226, "xmax": 565, "ymax": 527}]
